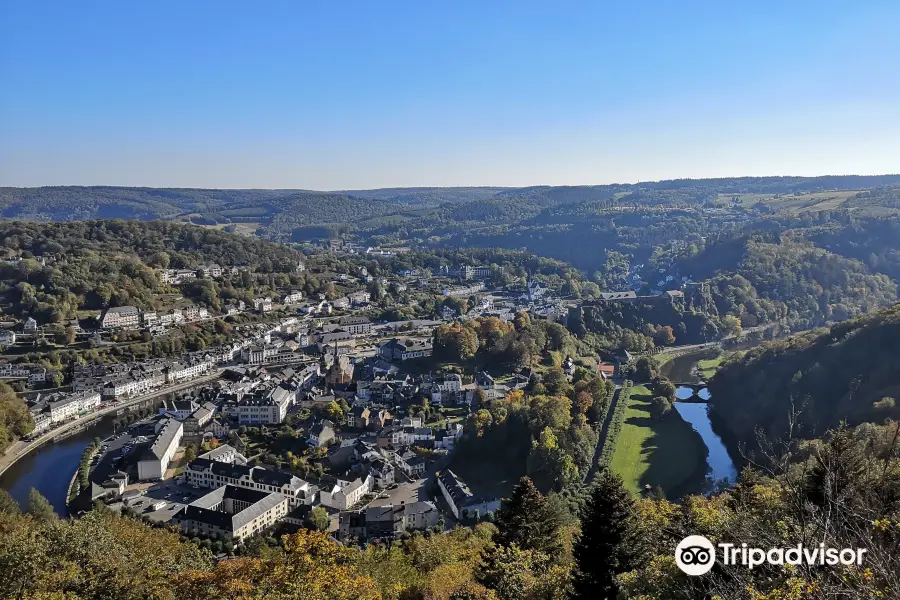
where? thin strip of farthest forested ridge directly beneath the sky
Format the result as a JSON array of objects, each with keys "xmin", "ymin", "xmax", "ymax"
[{"xmin": 0, "ymin": 175, "xmax": 900, "ymax": 227}]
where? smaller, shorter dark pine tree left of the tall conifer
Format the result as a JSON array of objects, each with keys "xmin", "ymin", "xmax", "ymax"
[{"xmin": 494, "ymin": 477, "xmax": 560, "ymax": 556}]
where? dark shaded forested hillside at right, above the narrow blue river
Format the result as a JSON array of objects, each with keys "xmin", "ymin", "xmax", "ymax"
[{"xmin": 709, "ymin": 305, "xmax": 900, "ymax": 448}]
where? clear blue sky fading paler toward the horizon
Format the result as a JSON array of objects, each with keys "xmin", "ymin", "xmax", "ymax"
[{"xmin": 0, "ymin": 0, "xmax": 900, "ymax": 189}]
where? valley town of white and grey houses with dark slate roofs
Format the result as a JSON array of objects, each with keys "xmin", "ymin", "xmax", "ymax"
[{"xmin": 0, "ymin": 251, "xmax": 644, "ymax": 543}]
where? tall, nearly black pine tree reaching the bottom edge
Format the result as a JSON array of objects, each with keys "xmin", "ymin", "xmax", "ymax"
[{"xmin": 570, "ymin": 470, "xmax": 638, "ymax": 600}]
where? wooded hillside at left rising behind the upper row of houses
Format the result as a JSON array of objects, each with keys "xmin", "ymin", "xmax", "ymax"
[{"xmin": 0, "ymin": 220, "xmax": 304, "ymax": 323}]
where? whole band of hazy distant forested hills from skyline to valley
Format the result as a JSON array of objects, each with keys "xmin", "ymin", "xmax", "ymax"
[{"xmin": 0, "ymin": 175, "xmax": 900, "ymax": 276}]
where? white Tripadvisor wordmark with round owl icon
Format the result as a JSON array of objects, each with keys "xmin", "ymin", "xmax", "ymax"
[{"xmin": 675, "ymin": 535, "xmax": 866, "ymax": 575}]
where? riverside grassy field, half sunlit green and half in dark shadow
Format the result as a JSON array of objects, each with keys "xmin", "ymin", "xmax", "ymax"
[{"xmin": 610, "ymin": 385, "xmax": 706, "ymax": 499}]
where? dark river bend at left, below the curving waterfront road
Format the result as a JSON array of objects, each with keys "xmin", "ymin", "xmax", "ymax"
[{"xmin": 0, "ymin": 394, "xmax": 172, "ymax": 516}]
